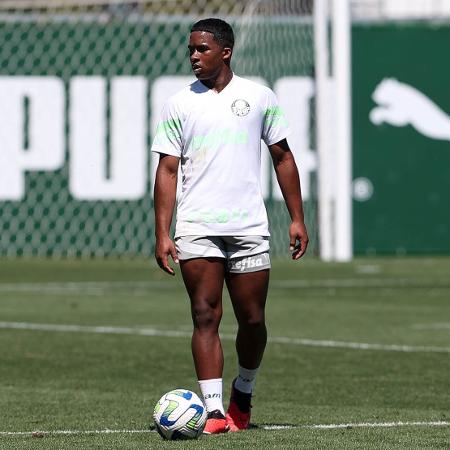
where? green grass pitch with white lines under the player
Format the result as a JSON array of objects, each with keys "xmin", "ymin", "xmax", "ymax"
[{"xmin": 0, "ymin": 258, "xmax": 450, "ymax": 450}]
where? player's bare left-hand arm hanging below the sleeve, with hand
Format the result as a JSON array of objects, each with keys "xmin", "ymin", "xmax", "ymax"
[{"xmin": 154, "ymin": 154, "xmax": 180, "ymax": 275}]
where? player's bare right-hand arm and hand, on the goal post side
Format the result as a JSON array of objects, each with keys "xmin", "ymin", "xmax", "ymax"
[{"xmin": 269, "ymin": 139, "xmax": 309, "ymax": 260}]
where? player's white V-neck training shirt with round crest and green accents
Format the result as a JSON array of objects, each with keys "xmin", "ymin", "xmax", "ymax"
[{"xmin": 152, "ymin": 75, "xmax": 289, "ymax": 237}]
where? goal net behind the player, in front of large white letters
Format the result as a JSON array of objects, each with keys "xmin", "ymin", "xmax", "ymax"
[{"xmin": 0, "ymin": 0, "xmax": 317, "ymax": 257}]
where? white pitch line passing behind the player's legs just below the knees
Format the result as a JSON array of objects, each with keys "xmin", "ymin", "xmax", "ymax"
[{"xmin": 0, "ymin": 322, "xmax": 450, "ymax": 353}]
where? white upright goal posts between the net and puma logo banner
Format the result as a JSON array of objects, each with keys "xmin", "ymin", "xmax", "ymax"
[{"xmin": 314, "ymin": 0, "xmax": 353, "ymax": 262}]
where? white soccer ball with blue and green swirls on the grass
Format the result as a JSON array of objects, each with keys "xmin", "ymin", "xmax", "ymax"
[{"xmin": 153, "ymin": 389, "xmax": 207, "ymax": 440}]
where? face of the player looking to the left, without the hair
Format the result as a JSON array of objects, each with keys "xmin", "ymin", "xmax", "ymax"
[{"xmin": 188, "ymin": 31, "xmax": 231, "ymax": 80}]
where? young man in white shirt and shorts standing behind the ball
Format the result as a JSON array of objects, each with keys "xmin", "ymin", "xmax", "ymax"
[{"xmin": 152, "ymin": 19, "xmax": 308, "ymax": 434}]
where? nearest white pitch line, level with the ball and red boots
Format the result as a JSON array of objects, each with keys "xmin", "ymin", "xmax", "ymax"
[{"xmin": 0, "ymin": 421, "xmax": 450, "ymax": 437}]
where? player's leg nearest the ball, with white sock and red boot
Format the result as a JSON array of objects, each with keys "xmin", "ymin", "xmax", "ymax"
[{"xmin": 180, "ymin": 248, "xmax": 228, "ymax": 434}]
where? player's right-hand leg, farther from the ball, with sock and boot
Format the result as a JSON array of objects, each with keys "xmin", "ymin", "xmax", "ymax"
[{"xmin": 226, "ymin": 269, "xmax": 269, "ymax": 431}]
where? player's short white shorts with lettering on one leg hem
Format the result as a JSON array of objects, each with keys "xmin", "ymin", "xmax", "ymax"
[{"xmin": 175, "ymin": 236, "xmax": 270, "ymax": 273}]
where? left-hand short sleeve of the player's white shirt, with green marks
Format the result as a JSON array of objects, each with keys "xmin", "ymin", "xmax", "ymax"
[{"xmin": 151, "ymin": 100, "xmax": 183, "ymax": 157}]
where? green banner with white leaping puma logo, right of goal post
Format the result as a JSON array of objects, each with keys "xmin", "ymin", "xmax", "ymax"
[{"xmin": 352, "ymin": 23, "xmax": 450, "ymax": 254}]
